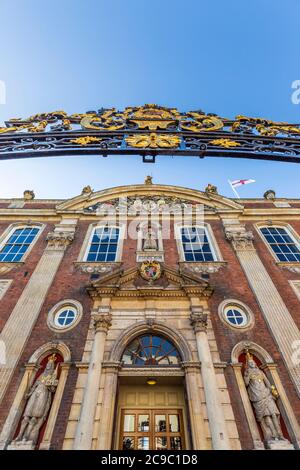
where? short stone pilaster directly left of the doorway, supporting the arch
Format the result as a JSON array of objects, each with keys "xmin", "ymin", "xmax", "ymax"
[{"xmin": 97, "ymin": 362, "xmax": 120, "ymax": 450}]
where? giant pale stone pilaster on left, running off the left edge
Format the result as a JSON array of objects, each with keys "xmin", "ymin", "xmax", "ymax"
[{"xmin": 0, "ymin": 219, "xmax": 77, "ymax": 402}]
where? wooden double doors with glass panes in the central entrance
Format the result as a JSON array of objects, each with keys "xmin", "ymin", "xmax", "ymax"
[{"xmin": 119, "ymin": 409, "xmax": 185, "ymax": 450}]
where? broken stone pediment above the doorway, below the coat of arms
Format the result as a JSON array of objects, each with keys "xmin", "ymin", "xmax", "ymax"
[{"xmin": 87, "ymin": 264, "xmax": 213, "ymax": 297}]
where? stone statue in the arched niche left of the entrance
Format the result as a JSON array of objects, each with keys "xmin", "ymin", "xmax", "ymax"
[{"xmin": 15, "ymin": 354, "xmax": 58, "ymax": 446}]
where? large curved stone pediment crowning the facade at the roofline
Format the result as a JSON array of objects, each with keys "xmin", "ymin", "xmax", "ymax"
[{"xmin": 56, "ymin": 184, "xmax": 243, "ymax": 214}]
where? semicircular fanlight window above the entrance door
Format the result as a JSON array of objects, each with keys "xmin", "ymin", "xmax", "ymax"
[{"xmin": 122, "ymin": 334, "xmax": 181, "ymax": 367}]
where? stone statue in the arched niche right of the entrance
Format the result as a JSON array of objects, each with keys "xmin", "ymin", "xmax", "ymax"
[{"xmin": 244, "ymin": 352, "xmax": 286, "ymax": 444}]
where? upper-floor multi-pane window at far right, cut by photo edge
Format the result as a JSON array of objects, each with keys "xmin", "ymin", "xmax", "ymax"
[{"xmin": 260, "ymin": 226, "xmax": 300, "ymax": 263}]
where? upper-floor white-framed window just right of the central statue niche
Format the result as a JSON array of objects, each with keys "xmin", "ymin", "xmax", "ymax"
[{"xmin": 179, "ymin": 226, "xmax": 217, "ymax": 262}]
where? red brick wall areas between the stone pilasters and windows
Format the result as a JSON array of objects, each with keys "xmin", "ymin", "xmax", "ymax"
[{"xmin": 0, "ymin": 211, "xmax": 300, "ymax": 449}]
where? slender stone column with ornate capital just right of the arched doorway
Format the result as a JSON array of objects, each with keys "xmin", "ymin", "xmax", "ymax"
[{"xmin": 190, "ymin": 307, "xmax": 230, "ymax": 450}]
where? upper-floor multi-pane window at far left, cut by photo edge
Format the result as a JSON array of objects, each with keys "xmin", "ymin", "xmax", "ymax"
[{"xmin": 0, "ymin": 226, "xmax": 39, "ymax": 263}]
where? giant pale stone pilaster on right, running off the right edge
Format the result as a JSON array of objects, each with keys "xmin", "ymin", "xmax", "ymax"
[{"xmin": 223, "ymin": 219, "xmax": 300, "ymax": 396}]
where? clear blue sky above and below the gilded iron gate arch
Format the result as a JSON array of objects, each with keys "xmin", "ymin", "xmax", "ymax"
[{"xmin": 0, "ymin": 0, "xmax": 300, "ymax": 198}]
